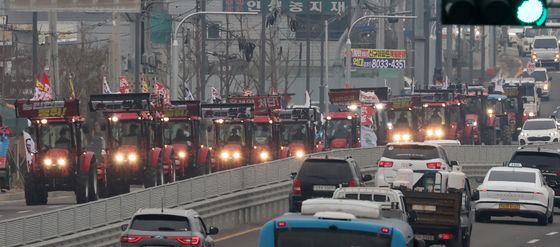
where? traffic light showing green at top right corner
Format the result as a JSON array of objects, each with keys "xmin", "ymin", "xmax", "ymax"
[{"xmin": 441, "ymin": 0, "xmax": 547, "ymax": 26}]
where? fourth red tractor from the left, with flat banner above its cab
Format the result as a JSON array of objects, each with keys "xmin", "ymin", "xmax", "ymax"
[{"xmin": 202, "ymin": 104, "xmax": 255, "ymax": 172}]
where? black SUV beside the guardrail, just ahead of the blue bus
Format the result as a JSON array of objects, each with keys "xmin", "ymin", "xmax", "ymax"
[{"xmin": 289, "ymin": 156, "xmax": 372, "ymax": 212}]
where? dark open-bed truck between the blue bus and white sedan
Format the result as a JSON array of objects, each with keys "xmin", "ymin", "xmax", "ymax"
[{"xmin": 392, "ymin": 166, "xmax": 474, "ymax": 247}]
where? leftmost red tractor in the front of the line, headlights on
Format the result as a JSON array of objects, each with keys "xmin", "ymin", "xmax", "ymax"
[{"xmin": 15, "ymin": 100, "xmax": 99, "ymax": 205}]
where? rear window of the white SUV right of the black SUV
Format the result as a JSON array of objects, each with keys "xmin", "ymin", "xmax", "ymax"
[{"xmin": 383, "ymin": 145, "xmax": 439, "ymax": 160}]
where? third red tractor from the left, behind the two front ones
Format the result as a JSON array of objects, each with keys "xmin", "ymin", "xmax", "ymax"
[{"xmin": 155, "ymin": 101, "xmax": 210, "ymax": 180}]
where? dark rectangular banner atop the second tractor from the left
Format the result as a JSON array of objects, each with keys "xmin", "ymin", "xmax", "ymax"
[{"xmin": 89, "ymin": 93, "xmax": 150, "ymax": 112}]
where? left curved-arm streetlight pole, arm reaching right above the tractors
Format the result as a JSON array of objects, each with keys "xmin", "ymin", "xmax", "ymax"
[{"xmin": 169, "ymin": 11, "xmax": 259, "ymax": 99}]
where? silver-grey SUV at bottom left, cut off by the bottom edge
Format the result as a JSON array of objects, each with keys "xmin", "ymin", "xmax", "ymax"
[{"xmin": 120, "ymin": 208, "xmax": 218, "ymax": 247}]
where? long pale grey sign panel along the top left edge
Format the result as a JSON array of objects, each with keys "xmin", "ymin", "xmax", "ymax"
[{"xmin": 5, "ymin": 0, "xmax": 141, "ymax": 13}]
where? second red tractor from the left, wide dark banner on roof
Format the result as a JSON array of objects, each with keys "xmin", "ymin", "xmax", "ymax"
[{"xmin": 90, "ymin": 93, "xmax": 168, "ymax": 196}]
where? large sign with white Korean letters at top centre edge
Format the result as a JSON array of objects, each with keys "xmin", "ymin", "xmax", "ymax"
[{"xmin": 223, "ymin": 0, "xmax": 350, "ymax": 15}]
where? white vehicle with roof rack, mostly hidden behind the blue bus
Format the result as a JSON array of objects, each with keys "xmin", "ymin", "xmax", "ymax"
[{"xmin": 333, "ymin": 187, "xmax": 411, "ymax": 221}]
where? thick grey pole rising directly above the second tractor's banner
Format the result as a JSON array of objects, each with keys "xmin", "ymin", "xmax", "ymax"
[{"xmin": 109, "ymin": 12, "xmax": 122, "ymax": 88}]
